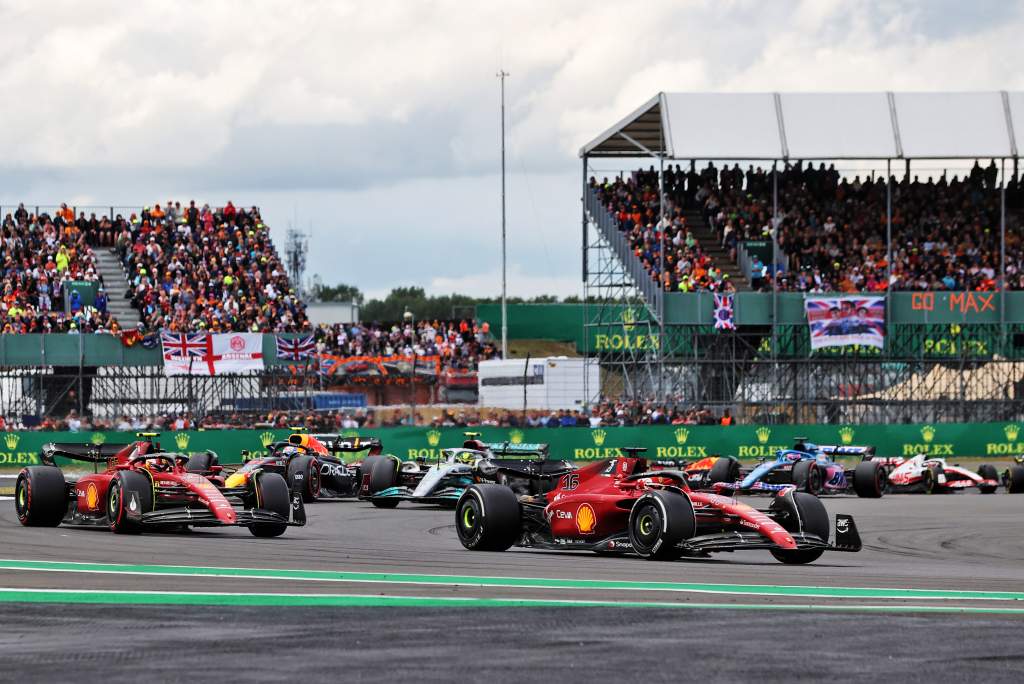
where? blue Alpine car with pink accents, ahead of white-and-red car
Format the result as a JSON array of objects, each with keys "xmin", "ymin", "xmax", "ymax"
[{"xmin": 712, "ymin": 438, "xmax": 886, "ymax": 499}]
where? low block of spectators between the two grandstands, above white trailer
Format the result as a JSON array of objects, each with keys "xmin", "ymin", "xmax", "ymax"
[{"xmin": 314, "ymin": 319, "xmax": 500, "ymax": 371}]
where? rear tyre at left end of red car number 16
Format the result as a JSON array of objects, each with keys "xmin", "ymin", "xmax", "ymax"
[{"xmin": 455, "ymin": 483, "xmax": 522, "ymax": 551}]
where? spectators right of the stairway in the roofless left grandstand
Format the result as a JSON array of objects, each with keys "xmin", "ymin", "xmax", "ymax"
[{"xmin": 114, "ymin": 201, "xmax": 309, "ymax": 333}]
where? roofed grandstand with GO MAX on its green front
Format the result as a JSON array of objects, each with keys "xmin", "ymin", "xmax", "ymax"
[{"xmin": 580, "ymin": 92, "xmax": 1024, "ymax": 423}]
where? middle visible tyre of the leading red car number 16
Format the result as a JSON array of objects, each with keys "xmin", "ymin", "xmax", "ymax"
[{"xmin": 629, "ymin": 490, "xmax": 697, "ymax": 560}]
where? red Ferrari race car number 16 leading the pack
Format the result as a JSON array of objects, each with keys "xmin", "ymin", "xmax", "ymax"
[{"xmin": 456, "ymin": 448, "xmax": 861, "ymax": 563}]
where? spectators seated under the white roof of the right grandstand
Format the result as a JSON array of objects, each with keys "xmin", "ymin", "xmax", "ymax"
[{"xmin": 591, "ymin": 162, "xmax": 1024, "ymax": 293}]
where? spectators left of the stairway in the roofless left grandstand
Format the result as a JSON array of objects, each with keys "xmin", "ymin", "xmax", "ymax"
[{"xmin": 0, "ymin": 204, "xmax": 117, "ymax": 334}]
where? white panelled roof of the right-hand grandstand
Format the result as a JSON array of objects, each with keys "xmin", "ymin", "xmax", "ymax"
[{"xmin": 580, "ymin": 91, "xmax": 1024, "ymax": 161}]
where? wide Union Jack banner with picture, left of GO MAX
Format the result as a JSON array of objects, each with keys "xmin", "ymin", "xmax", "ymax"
[{"xmin": 804, "ymin": 297, "xmax": 886, "ymax": 349}]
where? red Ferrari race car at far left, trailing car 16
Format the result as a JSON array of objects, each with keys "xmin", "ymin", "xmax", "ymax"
[{"xmin": 14, "ymin": 433, "xmax": 306, "ymax": 537}]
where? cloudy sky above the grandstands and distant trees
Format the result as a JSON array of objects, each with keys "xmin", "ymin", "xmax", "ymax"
[{"xmin": 0, "ymin": 0, "xmax": 1024, "ymax": 296}]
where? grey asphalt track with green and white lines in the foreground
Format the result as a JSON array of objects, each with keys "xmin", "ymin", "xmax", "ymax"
[{"xmin": 0, "ymin": 493, "xmax": 1024, "ymax": 682}]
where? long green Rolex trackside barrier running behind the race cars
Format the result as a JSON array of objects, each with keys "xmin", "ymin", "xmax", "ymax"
[{"xmin": 0, "ymin": 421, "xmax": 1024, "ymax": 468}]
